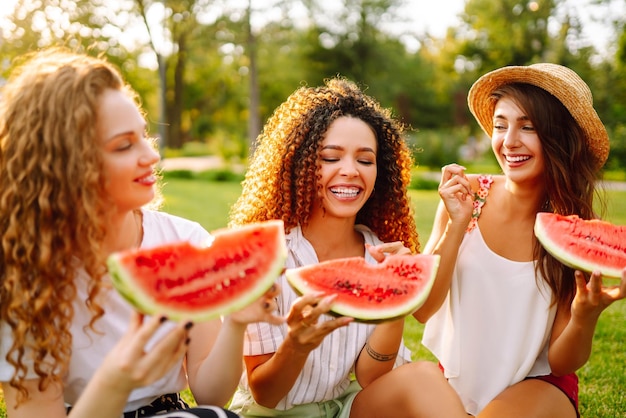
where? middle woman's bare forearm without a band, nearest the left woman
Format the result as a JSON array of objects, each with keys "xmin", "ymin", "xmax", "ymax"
[{"xmin": 248, "ymin": 337, "xmax": 308, "ymax": 408}]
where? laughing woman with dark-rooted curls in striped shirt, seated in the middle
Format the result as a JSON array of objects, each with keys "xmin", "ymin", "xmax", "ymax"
[{"xmin": 231, "ymin": 78, "xmax": 442, "ymax": 418}]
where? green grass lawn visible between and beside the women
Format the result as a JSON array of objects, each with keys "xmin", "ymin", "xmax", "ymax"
[{"xmin": 0, "ymin": 179, "xmax": 626, "ymax": 418}]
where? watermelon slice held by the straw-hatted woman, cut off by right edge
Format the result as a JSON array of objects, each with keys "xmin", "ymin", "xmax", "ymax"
[{"xmin": 535, "ymin": 212, "xmax": 626, "ymax": 278}]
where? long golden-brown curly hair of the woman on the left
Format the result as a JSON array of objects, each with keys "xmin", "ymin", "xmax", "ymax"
[{"xmin": 0, "ymin": 48, "xmax": 154, "ymax": 403}]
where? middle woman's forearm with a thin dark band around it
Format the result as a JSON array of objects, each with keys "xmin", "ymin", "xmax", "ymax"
[{"xmin": 355, "ymin": 318, "xmax": 404, "ymax": 387}]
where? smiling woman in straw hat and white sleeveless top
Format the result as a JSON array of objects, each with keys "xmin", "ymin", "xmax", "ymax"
[{"xmin": 404, "ymin": 63, "xmax": 626, "ymax": 418}]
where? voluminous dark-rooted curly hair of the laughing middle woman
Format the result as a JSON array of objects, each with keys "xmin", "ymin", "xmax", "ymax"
[{"xmin": 229, "ymin": 77, "xmax": 419, "ymax": 253}]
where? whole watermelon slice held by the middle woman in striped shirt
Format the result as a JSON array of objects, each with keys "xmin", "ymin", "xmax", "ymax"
[{"xmin": 285, "ymin": 254, "xmax": 440, "ymax": 322}]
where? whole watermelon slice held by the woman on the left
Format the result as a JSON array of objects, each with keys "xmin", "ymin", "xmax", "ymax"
[{"xmin": 107, "ymin": 220, "xmax": 287, "ymax": 321}]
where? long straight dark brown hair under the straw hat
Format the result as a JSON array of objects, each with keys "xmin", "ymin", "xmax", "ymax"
[{"xmin": 491, "ymin": 83, "xmax": 606, "ymax": 304}]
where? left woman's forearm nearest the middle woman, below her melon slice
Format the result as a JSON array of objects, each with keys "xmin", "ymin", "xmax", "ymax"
[{"xmin": 188, "ymin": 317, "xmax": 246, "ymax": 406}]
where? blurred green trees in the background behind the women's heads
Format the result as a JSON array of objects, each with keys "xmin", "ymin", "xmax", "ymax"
[{"xmin": 0, "ymin": 0, "xmax": 626, "ymax": 170}]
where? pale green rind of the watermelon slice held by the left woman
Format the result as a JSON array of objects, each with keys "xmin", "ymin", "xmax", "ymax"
[{"xmin": 107, "ymin": 220, "xmax": 287, "ymax": 322}]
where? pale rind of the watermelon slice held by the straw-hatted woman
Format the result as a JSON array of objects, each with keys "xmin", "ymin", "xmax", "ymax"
[{"xmin": 534, "ymin": 212, "xmax": 626, "ymax": 278}]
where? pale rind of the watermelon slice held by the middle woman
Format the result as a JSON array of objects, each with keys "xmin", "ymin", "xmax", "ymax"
[{"xmin": 285, "ymin": 254, "xmax": 441, "ymax": 324}]
